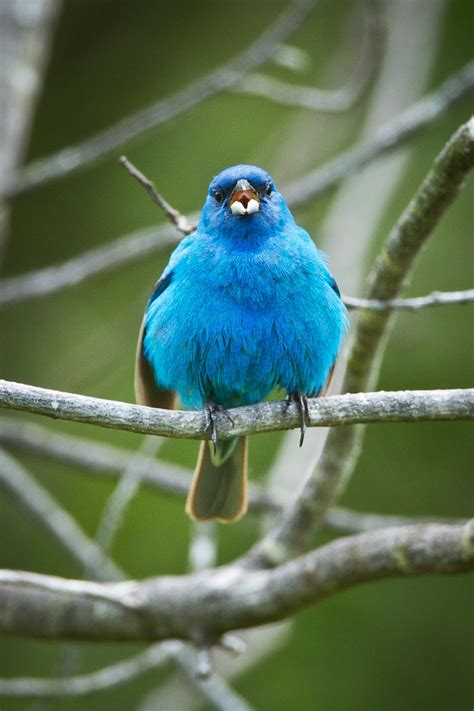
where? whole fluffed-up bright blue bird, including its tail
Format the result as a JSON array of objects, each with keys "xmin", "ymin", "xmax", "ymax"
[{"xmin": 135, "ymin": 165, "xmax": 347, "ymax": 522}]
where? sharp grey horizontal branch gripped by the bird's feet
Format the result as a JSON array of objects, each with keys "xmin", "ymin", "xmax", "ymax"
[{"xmin": 0, "ymin": 382, "xmax": 474, "ymax": 439}]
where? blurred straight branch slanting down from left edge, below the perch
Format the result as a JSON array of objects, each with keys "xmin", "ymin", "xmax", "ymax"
[{"xmin": 0, "ymin": 449, "xmax": 121, "ymax": 580}]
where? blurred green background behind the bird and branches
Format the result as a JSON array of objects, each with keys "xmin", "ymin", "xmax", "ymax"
[{"xmin": 0, "ymin": 0, "xmax": 474, "ymax": 711}]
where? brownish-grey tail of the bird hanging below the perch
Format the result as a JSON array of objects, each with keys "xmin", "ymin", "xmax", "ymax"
[{"xmin": 186, "ymin": 437, "xmax": 248, "ymax": 523}]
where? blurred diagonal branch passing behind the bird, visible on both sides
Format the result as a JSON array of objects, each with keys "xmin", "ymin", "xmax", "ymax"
[{"xmin": 0, "ymin": 62, "xmax": 474, "ymax": 309}]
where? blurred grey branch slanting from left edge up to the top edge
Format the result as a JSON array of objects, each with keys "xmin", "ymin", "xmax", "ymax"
[{"xmin": 0, "ymin": 0, "xmax": 316, "ymax": 197}]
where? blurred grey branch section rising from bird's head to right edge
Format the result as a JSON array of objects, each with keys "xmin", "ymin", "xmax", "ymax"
[{"xmin": 283, "ymin": 61, "xmax": 474, "ymax": 206}]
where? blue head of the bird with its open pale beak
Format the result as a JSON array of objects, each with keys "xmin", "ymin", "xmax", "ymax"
[{"xmin": 201, "ymin": 165, "xmax": 292, "ymax": 237}]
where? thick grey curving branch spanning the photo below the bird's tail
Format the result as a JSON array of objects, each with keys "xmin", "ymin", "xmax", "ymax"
[{"xmin": 0, "ymin": 522, "xmax": 474, "ymax": 642}]
